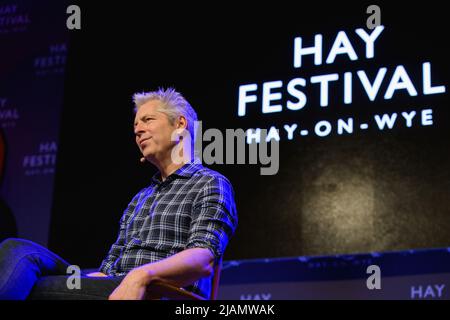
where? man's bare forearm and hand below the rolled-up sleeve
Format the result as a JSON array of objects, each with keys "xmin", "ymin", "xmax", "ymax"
[{"xmin": 109, "ymin": 248, "xmax": 214, "ymax": 300}]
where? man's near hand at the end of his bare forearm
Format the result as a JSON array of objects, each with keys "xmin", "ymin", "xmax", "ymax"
[{"xmin": 108, "ymin": 267, "xmax": 150, "ymax": 300}]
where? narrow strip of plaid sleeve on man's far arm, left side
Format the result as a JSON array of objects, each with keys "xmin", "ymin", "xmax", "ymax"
[{"xmin": 99, "ymin": 189, "xmax": 144, "ymax": 275}]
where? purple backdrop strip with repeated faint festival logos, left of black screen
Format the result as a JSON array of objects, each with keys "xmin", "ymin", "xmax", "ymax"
[{"xmin": 0, "ymin": 1, "xmax": 69, "ymax": 245}]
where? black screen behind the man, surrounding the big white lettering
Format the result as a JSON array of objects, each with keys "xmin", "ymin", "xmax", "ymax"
[{"xmin": 49, "ymin": 1, "xmax": 450, "ymax": 266}]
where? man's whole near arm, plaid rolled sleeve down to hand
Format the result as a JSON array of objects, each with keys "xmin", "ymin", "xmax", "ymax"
[{"xmin": 110, "ymin": 172, "xmax": 237, "ymax": 300}]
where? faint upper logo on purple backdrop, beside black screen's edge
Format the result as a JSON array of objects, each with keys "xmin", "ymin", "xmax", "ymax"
[{"xmin": 34, "ymin": 43, "xmax": 67, "ymax": 76}]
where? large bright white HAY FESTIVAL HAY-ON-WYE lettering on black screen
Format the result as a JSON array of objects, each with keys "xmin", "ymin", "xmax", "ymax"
[{"xmin": 237, "ymin": 22, "xmax": 446, "ymax": 142}]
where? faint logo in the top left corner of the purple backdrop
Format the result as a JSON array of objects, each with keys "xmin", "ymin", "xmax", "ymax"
[{"xmin": 0, "ymin": 4, "xmax": 31, "ymax": 34}]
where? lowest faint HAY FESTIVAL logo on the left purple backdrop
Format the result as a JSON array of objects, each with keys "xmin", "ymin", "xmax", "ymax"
[{"xmin": 22, "ymin": 141, "xmax": 57, "ymax": 176}]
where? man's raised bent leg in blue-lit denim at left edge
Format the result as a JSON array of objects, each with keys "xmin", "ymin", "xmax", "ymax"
[{"xmin": 0, "ymin": 238, "xmax": 70, "ymax": 300}]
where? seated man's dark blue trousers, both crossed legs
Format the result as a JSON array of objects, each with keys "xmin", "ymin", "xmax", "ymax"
[{"xmin": 0, "ymin": 238, "xmax": 124, "ymax": 300}]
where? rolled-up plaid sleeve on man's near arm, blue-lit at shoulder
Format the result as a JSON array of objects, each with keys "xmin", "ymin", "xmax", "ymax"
[{"xmin": 186, "ymin": 176, "xmax": 238, "ymax": 261}]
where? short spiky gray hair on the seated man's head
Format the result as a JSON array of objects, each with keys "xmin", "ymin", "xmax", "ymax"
[{"xmin": 133, "ymin": 88, "xmax": 197, "ymax": 141}]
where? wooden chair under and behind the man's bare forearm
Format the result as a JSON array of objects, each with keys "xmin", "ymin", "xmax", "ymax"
[{"xmin": 147, "ymin": 258, "xmax": 222, "ymax": 300}]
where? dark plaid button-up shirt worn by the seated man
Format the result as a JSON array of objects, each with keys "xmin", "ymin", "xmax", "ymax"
[{"xmin": 99, "ymin": 163, "xmax": 237, "ymax": 298}]
